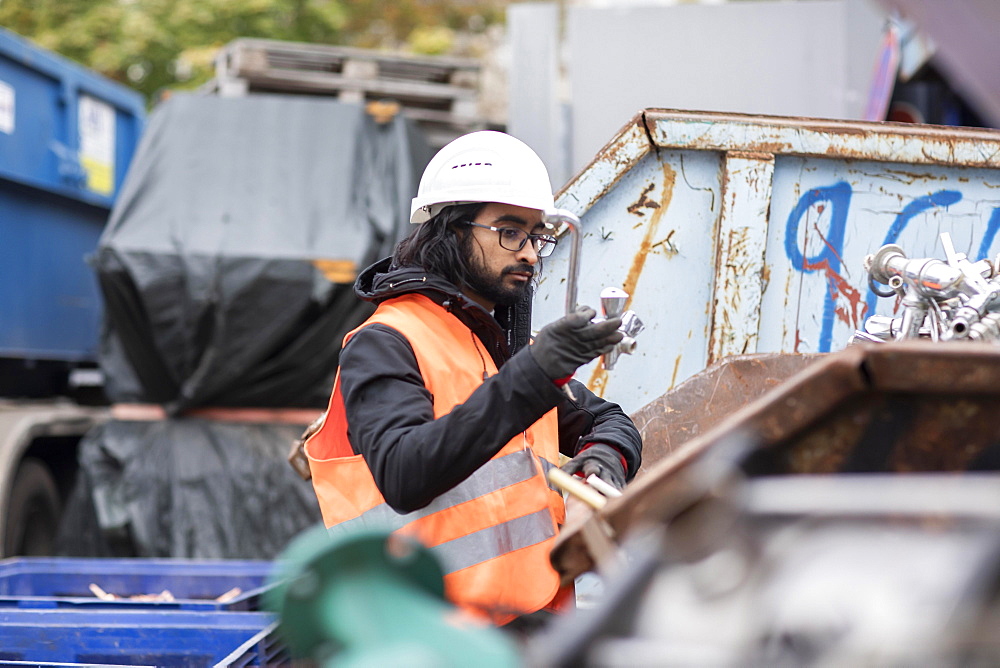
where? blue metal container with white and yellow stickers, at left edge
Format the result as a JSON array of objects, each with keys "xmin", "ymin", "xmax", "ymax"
[{"xmin": 0, "ymin": 29, "xmax": 145, "ymax": 361}]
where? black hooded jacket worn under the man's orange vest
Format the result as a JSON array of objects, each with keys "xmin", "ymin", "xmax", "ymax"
[{"xmin": 340, "ymin": 259, "xmax": 642, "ymax": 512}]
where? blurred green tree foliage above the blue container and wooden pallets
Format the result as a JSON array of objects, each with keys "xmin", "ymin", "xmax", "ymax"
[{"xmin": 0, "ymin": 0, "xmax": 508, "ymax": 99}]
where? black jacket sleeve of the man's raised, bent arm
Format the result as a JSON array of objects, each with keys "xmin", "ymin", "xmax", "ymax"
[{"xmin": 340, "ymin": 324, "xmax": 565, "ymax": 513}]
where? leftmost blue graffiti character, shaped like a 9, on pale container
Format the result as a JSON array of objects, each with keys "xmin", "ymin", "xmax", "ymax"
[{"xmin": 785, "ymin": 181, "xmax": 851, "ymax": 353}]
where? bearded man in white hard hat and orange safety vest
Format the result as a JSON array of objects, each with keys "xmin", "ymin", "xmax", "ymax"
[{"xmin": 305, "ymin": 131, "xmax": 642, "ymax": 624}]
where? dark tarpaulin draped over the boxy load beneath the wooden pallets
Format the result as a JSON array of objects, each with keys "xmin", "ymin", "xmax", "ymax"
[{"xmin": 95, "ymin": 95, "xmax": 429, "ymax": 414}]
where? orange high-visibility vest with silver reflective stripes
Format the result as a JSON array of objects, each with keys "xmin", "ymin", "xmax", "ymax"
[{"xmin": 304, "ymin": 294, "xmax": 566, "ymax": 624}]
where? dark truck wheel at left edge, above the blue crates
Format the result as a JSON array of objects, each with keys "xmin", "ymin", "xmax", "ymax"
[{"xmin": 4, "ymin": 457, "xmax": 60, "ymax": 557}]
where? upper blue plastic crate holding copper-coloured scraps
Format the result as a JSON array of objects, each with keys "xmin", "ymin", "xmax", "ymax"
[{"xmin": 0, "ymin": 557, "xmax": 275, "ymax": 611}]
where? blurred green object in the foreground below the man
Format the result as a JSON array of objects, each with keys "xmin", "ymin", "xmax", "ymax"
[{"xmin": 265, "ymin": 528, "xmax": 521, "ymax": 668}]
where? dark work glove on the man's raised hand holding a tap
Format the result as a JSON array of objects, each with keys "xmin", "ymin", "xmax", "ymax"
[{"xmin": 528, "ymin": 306, "xmax": 625, "ymax": 380}]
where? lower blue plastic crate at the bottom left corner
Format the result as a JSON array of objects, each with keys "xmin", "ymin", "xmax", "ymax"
[{"xmin": 0, "ymin": 609, "xmax": 288, "ymax": 668}]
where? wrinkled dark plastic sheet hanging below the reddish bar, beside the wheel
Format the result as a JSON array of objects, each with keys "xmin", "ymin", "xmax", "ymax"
[{"xmin": 57, "ymin": 418, "xmax": 321, "ymax": 559}]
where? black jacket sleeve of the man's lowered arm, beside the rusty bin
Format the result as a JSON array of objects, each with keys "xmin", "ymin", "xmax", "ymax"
[{"xmin": 559, "ymin": 380, "xmax": 642, "ymax": 480}]
